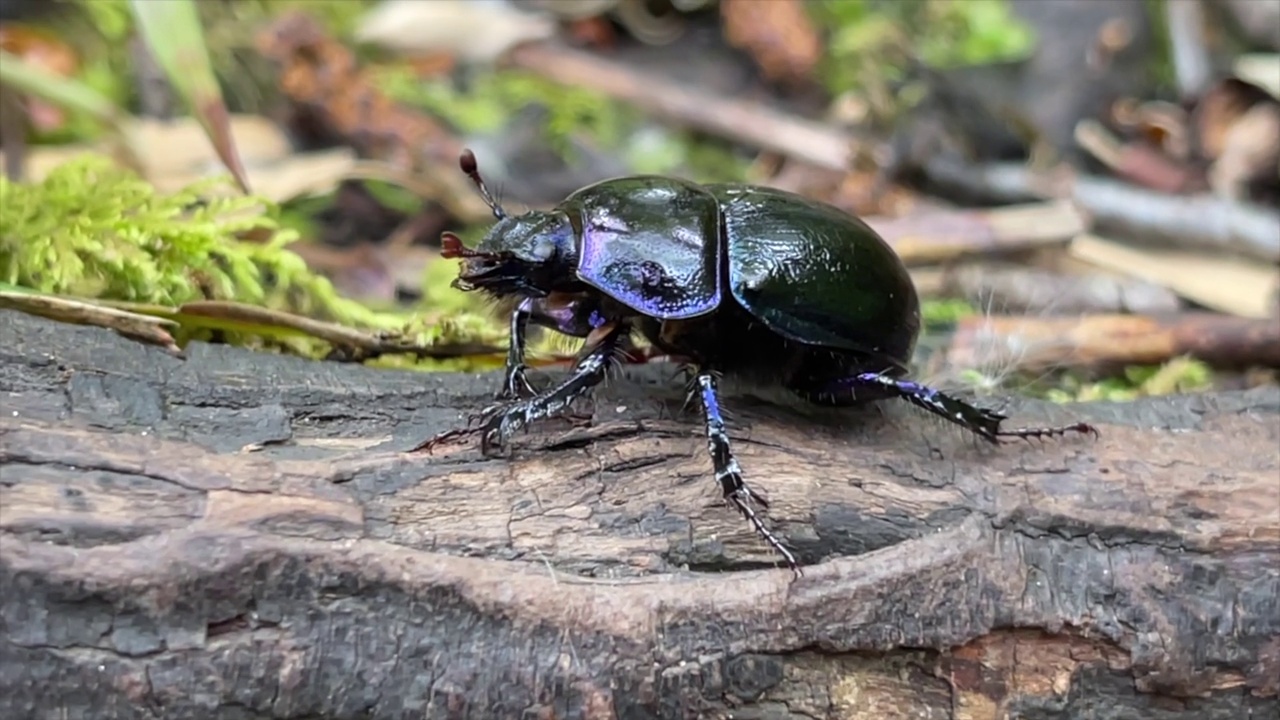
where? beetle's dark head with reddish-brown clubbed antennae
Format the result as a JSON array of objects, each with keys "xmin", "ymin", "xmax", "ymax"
[{"xmin": 443, "ymin": 150, "xmax": 573, "ymax": 296}]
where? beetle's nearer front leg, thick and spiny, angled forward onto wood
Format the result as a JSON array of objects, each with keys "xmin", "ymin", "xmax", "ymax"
[{"xmin": 480, "ymin": 323, "xmax": 628, "ymax": 455}]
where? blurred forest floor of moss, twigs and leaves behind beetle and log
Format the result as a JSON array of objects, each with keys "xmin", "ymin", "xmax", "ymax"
[{"xmin": 0, "ymin": 0, "xmax": 1280, "ymax": 401}]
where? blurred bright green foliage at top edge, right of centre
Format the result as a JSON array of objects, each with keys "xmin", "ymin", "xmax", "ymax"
[{"xmin": 806, "ymin": 0, "xmax": 1036, "ymax": 94}]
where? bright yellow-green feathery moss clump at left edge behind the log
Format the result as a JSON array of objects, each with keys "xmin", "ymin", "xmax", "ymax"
[{"xmin": 0, "ymin": 155, "xmax": 320, "ymax": 310}]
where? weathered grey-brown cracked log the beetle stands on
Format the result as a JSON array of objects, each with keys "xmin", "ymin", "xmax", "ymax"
[{"xmin": 0, "ymin": 311, "xmax": 1280, "ymax": 720}]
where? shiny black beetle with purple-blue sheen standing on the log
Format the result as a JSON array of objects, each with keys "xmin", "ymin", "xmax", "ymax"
[{"xmin": 420, "ymin": 150, "xmax": 1097, "ymax": 574}]
